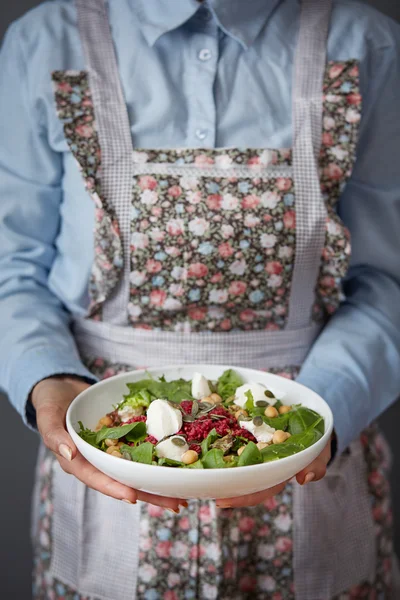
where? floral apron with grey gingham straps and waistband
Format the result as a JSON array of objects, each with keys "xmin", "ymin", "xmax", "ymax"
[{"xmin": 33, "ymin": 0, "xmax": 392, "ymax": 600}]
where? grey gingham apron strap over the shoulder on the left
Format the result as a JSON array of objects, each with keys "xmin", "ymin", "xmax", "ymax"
[{"xmin": 75, "ymin": 0, "xmax": 133, "ymax": 325}]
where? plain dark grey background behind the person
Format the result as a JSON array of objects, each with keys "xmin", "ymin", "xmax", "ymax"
[{"xmin": 0, "ymin": 0, "xmax": 400, "ymax": 600}]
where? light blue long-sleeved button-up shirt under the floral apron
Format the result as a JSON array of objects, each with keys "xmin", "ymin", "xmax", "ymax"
[{"xmin": 0, "ymin": 0, "xmax": 400, "ymax": 450}]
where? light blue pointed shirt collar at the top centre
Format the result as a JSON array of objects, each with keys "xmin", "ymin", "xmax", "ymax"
[{"xmin": 132, "ymin": 0, "xmax": 282, "ymax": 48}]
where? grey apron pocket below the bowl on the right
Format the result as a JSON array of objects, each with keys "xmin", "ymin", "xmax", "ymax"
[{"xmin": 293, "ymin": 440, "xmax": 376, "ymax": 600}]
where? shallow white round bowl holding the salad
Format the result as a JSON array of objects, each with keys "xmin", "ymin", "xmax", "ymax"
[{"xmin": 67, "ymin": 365, "xmax": 333, "ymax": 499}]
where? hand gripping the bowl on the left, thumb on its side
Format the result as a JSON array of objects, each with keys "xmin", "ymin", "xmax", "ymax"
[{"xmin": 32, "ymin": 376, "xmax": 186, "ymax": 512}]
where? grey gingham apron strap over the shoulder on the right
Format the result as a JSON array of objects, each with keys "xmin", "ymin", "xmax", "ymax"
[{"xmin": 287, "ymin": 0, "xmax": 332, "ymax": 329}]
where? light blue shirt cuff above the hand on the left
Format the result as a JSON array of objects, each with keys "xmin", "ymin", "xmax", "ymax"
[{"xmin": 9, "ymin": 346, "xmax": 98, "ymax": 430}]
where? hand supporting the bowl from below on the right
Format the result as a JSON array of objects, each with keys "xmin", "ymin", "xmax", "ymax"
[{"xmin": 217, "ymin": 442, "xmax": 331, "ymax": 508}]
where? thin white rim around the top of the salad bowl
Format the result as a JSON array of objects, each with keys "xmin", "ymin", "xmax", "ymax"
[{"xmin": 66, "ymin": 364, "xmax": 333, "ymax": 479}]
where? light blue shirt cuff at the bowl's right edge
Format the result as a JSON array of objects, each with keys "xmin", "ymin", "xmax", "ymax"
[{"xmin": 297, "ymin": 368, "xmax": 360, "ymax": 455}]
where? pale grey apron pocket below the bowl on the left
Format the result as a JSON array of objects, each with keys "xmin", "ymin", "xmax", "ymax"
[{"xmin": 50, "ymin": 462, "xmax": 140, "ymax": 600}]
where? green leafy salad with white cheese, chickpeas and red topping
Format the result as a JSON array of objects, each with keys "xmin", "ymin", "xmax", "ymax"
[{"xmin": 78, "ymin": 369, "xmax": 325, "ymax": 469}]
